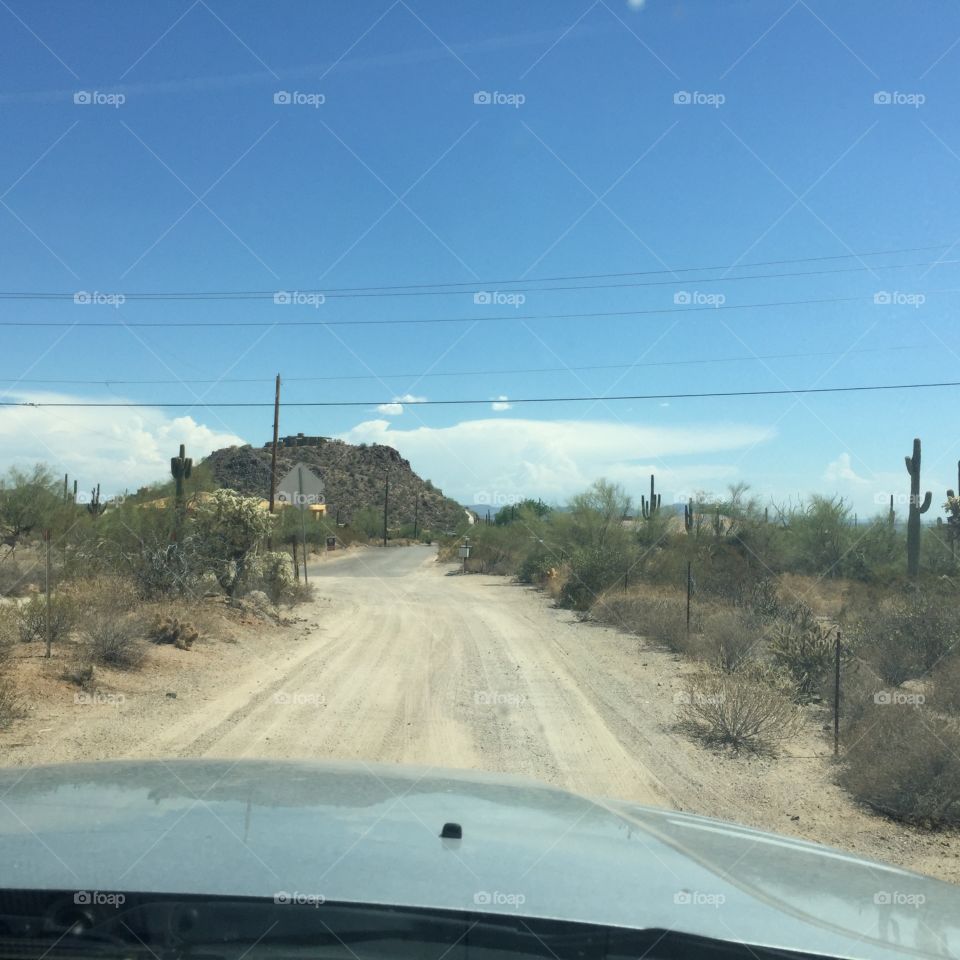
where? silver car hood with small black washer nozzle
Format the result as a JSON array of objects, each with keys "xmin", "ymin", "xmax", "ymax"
[{"xmin": 0, "ymin": 760, "xmax": 960, "ymax": 958}]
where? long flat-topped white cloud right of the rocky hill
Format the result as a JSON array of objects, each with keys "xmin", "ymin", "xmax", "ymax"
[{"xmin": 341, "ymin": 417, "xmax": 775, "ymax": 503}]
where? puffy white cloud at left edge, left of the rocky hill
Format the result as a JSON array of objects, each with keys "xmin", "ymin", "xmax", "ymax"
[{"xmin": 0, "ymin": 393, "xmax": 246, "ymax": 495}]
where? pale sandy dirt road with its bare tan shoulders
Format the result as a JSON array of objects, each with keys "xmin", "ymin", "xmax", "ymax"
[{"xmin": 0, "ymin": 547, "xmax": 960, "ymax": 882}]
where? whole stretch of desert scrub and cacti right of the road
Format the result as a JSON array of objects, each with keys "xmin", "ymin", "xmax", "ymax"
[{"xmin": 442, "ymin": 442, "xmax": 960, "ymax": 827}]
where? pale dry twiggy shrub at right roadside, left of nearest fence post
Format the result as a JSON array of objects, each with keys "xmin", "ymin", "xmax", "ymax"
[{"xmin": 678, "ymin": 673, "xmax": 801, "ymax": 751}]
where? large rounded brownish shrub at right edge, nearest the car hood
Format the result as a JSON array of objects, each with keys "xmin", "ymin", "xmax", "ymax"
[{"xmin": 840, "ymin": 703, "xmax": 960, "ymax": 826}]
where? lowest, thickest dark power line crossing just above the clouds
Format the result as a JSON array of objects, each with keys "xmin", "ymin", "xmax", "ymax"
[{"xmin": 0, "ymin": 380, "xmax": 960, "ymax": 409}]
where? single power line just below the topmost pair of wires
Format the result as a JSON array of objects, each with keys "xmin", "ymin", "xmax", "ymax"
[{"xmin": 0, "ymin": 289, "xmax": 960, "ymax": 330}]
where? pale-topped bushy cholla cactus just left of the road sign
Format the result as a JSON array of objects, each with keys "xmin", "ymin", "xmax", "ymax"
[{"xmin": 194, "ymin": 490, "xmax": 274, "ymax": 600}]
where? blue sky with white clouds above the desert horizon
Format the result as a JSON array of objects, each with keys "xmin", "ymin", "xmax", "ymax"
[{"xmin": 0, "ymin": 0, "xmax": 960, "ymax": 515}]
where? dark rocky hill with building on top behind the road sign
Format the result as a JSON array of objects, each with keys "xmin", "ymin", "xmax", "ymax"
[{"xmin": 203, "ymin": 437, "xmax": 464, "ymax": 530}]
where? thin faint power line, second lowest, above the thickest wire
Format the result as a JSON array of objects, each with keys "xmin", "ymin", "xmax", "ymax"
[{"xmin": 0, "ymin": 344, "xmax": 934, "ymax": 387}]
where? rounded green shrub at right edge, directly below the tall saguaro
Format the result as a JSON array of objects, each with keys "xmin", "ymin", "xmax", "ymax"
[{"xmin": 853, "ymin": 591, "xmax": 960, "ymax": 686}]
